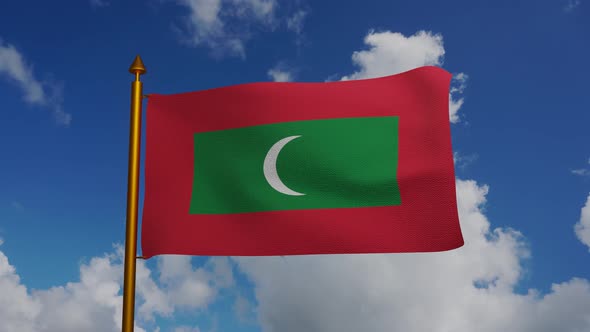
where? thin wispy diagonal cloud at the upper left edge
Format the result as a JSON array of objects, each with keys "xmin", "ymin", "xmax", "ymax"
[{"xmin": 0, "ymin": 39, "xmax": 72, "ymax": 125}]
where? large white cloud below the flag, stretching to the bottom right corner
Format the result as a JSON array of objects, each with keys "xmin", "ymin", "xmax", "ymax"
[{"xmin": 236, "ymin": 180, "xmax": 590, "ymax": 332}]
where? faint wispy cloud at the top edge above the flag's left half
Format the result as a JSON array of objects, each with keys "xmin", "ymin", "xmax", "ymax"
[{"xmin": 179, "ymin": 0, "xmax": 277, "ymax": 57}]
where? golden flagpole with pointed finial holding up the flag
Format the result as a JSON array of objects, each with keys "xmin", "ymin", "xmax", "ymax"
[{"xmin": 122, "ymin": 55, "xmax": 146, "ymax": 332}]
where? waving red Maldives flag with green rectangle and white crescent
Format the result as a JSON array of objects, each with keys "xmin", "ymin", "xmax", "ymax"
[{"xmin": 141, "ymin": 67, "xmax": 463, "ymax": 258}]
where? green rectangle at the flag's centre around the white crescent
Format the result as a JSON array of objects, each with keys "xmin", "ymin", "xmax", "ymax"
[{"xmin": 189, "ymin": 116, "xmax": 401, "ymax": 214}]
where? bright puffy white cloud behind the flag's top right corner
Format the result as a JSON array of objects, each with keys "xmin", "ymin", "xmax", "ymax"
[{"xmin": 341, "ymin": 31, "xmax": 468, "ymax": 123}]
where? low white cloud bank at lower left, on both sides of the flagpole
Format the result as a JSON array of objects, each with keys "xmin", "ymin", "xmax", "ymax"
[{"xmin": 0, "ymin": 246, "xmax": 233, "ymax": 332}]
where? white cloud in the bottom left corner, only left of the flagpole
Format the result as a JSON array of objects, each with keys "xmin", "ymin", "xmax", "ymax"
[{"xmin": 0, "ymin": 245, "xmax": 144, "ymax": 332}]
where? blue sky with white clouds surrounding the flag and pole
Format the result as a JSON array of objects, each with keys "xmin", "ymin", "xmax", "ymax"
[{"xmin": 0, "ymin": 0, "xmax": 590, "ymax": 332}]
